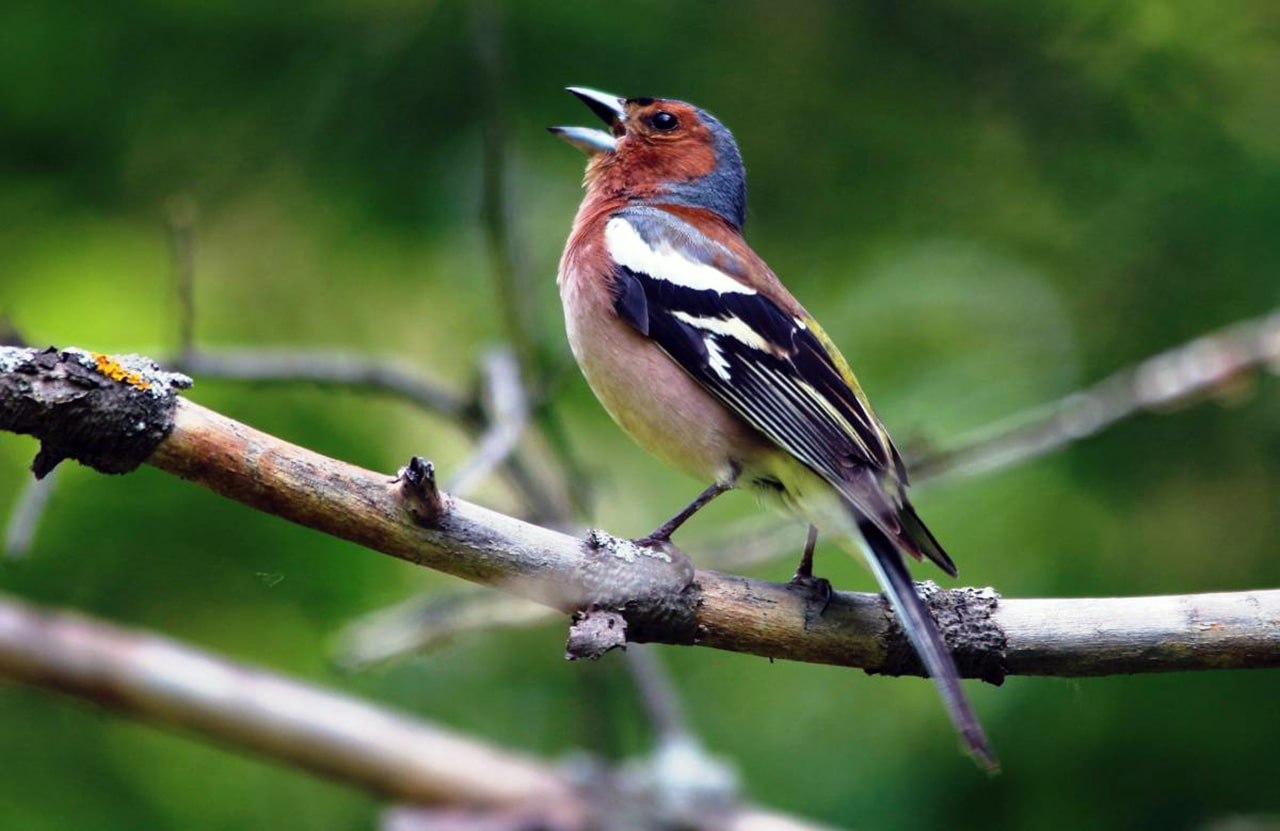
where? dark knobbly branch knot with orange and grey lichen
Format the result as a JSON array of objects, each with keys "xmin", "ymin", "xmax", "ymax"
[{"xmin": 0, "ymin": 347, "xmax": 191, "ymax": 479}]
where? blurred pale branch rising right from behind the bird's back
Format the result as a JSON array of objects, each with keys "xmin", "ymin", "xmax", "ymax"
[{"xmin": 910, "ymin": 310, "xmax": 1280, "ymax": 483}]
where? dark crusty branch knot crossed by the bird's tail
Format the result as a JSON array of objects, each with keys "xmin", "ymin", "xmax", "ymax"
[{"xmin": 867, "ymin": 580, "xmax": 1009, "ymax": 686}]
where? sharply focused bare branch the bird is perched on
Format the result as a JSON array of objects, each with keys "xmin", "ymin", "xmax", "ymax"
[{"xmin": 0, "ymin": 347, "xmax": 1280, "ymax": 682}]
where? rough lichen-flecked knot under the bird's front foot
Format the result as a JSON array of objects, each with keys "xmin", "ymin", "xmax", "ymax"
[{"xmin": 566, "ymin": 529, "xmax": 699, "ymax": 659}]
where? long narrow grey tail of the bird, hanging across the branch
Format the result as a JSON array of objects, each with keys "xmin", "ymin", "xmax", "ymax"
[{"xmin": 859, "ymin": 517, "xmax": 1000, "ymax": 771}]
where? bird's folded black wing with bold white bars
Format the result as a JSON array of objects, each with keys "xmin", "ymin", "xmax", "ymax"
[{"xmin": 605, "ymin": 207, "xmax": 901, "ymax": 512}]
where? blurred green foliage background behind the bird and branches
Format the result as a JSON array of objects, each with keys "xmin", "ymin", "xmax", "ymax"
[{"xmin": 0, "ymin": 0, "xmax": 1280, "ymax": 831}]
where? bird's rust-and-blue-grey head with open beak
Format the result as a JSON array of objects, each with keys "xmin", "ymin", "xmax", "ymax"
[{"xmin": 549, "ymin": 87, "xmax": 746, "ymax": 228}]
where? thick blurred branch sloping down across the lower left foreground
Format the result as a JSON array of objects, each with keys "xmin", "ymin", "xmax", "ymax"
[{"xmin": 0, "ymin": 595, "xmax": 814, "ymax": 831}]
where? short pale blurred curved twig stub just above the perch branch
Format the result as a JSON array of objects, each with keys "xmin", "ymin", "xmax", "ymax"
[{"xmin": 449, "ymin": 350, "xmax": 529, "ymax": 496}]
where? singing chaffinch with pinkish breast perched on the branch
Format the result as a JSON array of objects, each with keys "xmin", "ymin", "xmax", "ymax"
[{"xmin": 548, "ymin": 87, "xmax": 998, "ymax": 771}]
